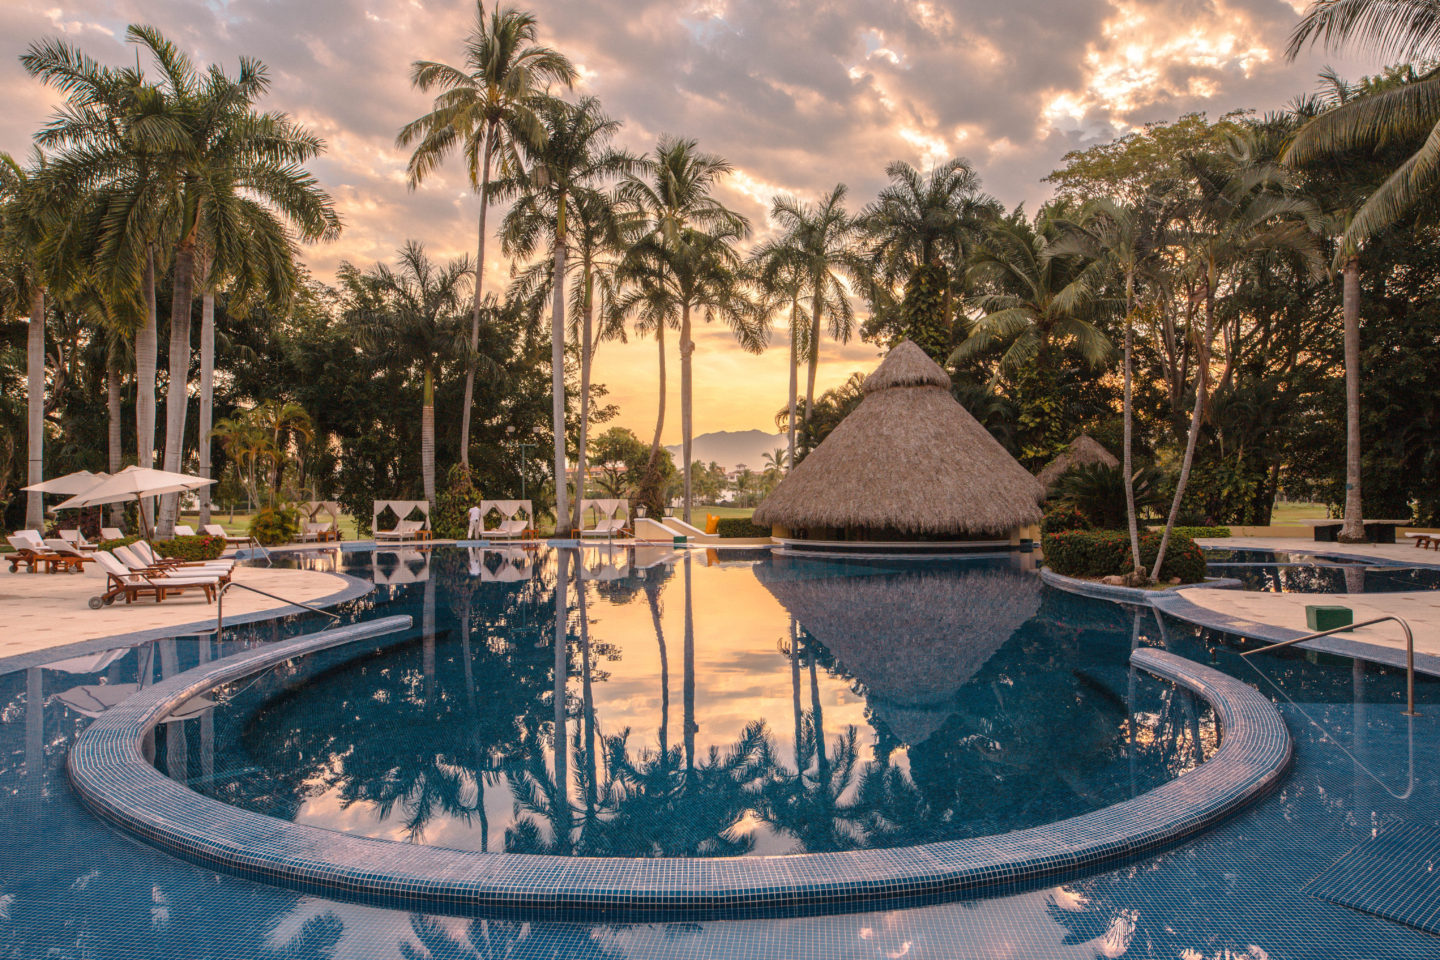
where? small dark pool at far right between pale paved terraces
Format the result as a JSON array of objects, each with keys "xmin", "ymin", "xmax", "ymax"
[{"xmin": 1205, "ymin": 548, "xmax": 1440, "ymax": 593}]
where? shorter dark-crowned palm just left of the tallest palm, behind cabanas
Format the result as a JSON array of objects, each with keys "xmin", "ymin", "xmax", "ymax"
[{"xmin": 338, "ymin": 240, "xmax": 471, "ymax": 504}]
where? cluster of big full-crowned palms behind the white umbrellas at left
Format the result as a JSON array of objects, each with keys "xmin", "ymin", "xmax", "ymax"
[{"xmin": 0, "ymin": 26, "xmax": 340, "ymax": 535}]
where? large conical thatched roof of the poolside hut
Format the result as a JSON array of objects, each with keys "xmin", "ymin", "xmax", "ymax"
[{"xmin": 755, "ymin": 340, "xmax": 1043, "ymax": 535}]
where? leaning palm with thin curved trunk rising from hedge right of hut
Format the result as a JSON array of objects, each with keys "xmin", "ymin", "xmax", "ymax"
[{"xmin": 1151, "ymin": 151, "xmax": 1320, "ymax": 580}]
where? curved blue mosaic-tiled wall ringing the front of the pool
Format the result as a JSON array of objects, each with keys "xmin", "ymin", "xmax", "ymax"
[{"xmin": 68, "ymin": 617, "xmax": 1292, "ymax": 920}]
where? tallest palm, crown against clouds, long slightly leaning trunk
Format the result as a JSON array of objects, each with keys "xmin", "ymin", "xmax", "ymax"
[{"xmin": 395, "ymin": 0, "xmax": 576, "ymax": 468}]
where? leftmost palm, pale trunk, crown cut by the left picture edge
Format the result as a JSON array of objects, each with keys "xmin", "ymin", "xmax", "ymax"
[{"xmin": 0, "ymin": 153, "xmax": 55, "ymax": 530}]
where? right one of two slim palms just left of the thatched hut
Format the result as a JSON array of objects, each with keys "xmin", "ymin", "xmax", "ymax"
[{"xmin": 770, "ymin": 183, "xmax": 858, "ymax": 451}]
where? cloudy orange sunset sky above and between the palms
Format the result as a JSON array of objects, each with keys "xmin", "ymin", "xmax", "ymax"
[{"xmin": 0, "ymin": 0, "xmax": 1380, "ymax": 442}]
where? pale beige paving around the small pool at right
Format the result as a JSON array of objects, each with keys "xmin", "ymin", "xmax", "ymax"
[{"xmin": 1182, "ymin": 537, "xmax": 1440, "ymax": 656}]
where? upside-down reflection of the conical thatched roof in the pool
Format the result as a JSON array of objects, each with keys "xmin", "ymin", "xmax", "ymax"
[{"xmin": 755, "ymin": 557, "xmax": 1041, "ymax": 744}]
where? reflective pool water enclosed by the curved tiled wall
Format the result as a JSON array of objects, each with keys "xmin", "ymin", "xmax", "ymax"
[{"xmin": 154, "ymin": 547, "xmax": 1217, "ymax": 856}]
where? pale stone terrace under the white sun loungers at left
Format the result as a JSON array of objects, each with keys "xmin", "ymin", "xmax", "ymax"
[{"xmin": 0, "ymin": 564, "xmax": 350, "ymax": 659}]
